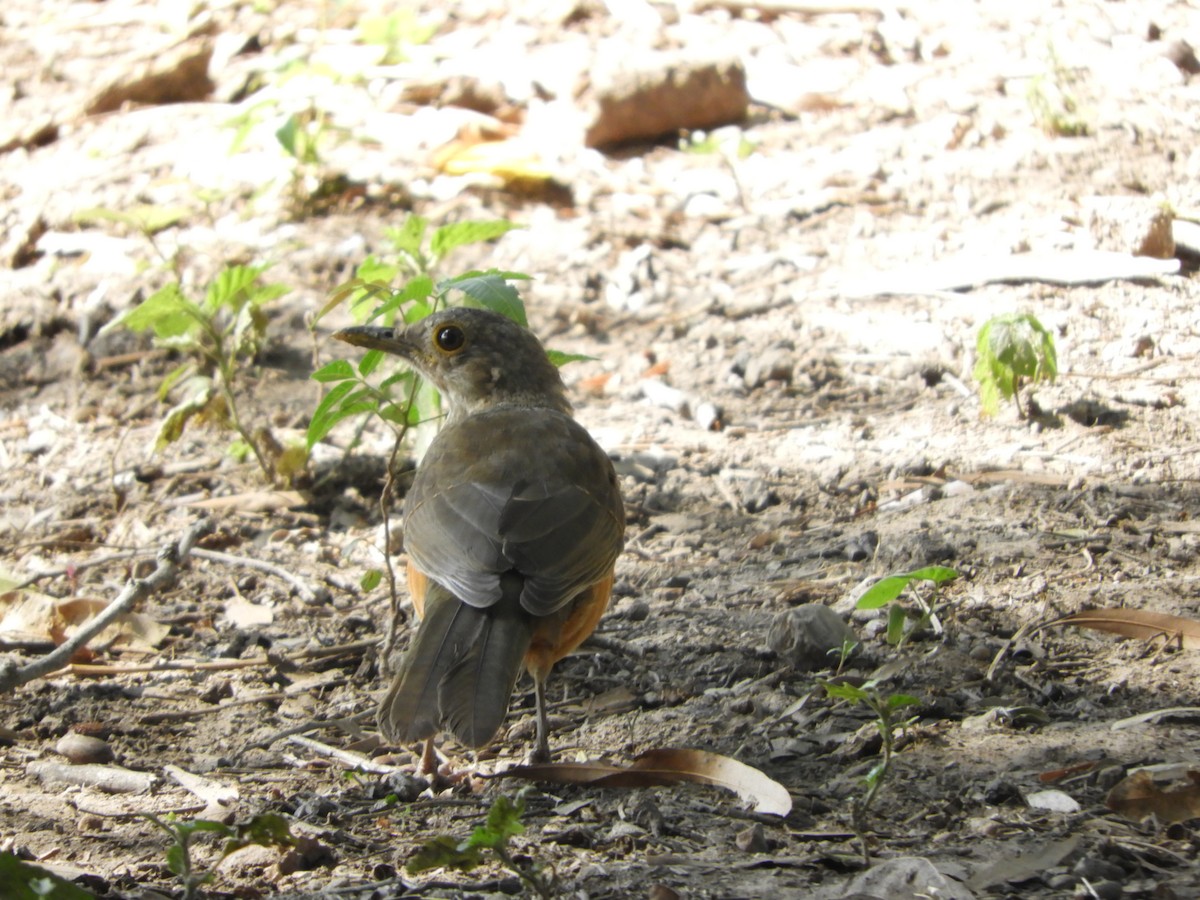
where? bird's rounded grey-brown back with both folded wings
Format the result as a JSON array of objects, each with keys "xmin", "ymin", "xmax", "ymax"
[{"xmin": 404, "ymin": 409, "xmax": 624, "ymax": 616}]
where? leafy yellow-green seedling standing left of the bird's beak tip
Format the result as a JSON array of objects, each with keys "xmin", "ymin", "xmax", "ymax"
[{"xmin": 103, "ymin": 265, "xmax": 307, "ymax": 484}]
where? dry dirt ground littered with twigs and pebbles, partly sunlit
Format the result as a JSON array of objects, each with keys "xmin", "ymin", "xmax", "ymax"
[{"xmin": 0, "ymin": 0, "xmax": 1200, "ymax": 900}]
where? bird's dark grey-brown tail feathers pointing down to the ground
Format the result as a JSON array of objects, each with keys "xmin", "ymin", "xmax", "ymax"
[{"xmin": 378, "ymin": 575, "xmax": 533, "ymax": 746}]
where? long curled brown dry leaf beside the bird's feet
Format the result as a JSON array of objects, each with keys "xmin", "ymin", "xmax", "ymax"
[{"xmin": 496, "ymin": 748, "xmax": 792, "ymax": 816}]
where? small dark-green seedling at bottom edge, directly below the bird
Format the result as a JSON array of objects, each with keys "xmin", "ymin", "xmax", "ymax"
[{"xmin": 404, "ymin": 788, "xmax": 554, "ymax": 898}]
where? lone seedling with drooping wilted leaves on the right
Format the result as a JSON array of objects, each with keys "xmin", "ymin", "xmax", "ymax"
[{"xmin": 974, "ymin": 313, "xmax": 1058, "ymax": 419}]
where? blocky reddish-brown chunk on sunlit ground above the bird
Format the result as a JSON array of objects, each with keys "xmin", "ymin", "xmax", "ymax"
[{"xmin": 584, "ymin": 53, "xmax": 750, "ymax": 148}]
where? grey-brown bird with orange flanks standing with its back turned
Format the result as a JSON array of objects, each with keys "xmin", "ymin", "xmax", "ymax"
[{"xmin": 334, "ymin": 307, "xmax": 625, "ymax": 762}]
